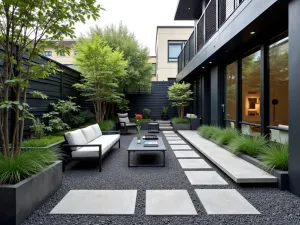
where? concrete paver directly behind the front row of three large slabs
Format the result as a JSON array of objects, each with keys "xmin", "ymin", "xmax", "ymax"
[{"xmin": 185, "ymin": 171, "xmax": 228, "ymax": 185}]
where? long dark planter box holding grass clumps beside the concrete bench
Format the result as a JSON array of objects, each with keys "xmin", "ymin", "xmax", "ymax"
[{"xmin": 199, "ymin": 134, "xmax": 289, "ymax": 191}]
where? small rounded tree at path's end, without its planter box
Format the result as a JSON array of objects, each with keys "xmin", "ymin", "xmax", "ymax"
[{"xmin": 168, "ymin": 82, "xmax": 193, "ymax": 118}]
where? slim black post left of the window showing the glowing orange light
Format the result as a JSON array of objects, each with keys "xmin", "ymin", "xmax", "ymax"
[{"xmin": 235, "ymin": 58, "xmax": 243, "ymax": 130}]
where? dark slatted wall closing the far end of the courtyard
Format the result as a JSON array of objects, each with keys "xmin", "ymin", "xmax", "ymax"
[{"xmin": 126, "ymin": 81, "xmax": 178, "ymax": 119}]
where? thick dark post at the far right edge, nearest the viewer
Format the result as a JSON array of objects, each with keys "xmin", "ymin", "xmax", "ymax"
[{"xmin": 288, "ymin": 0, "xmax": 300, "ymax": 196}]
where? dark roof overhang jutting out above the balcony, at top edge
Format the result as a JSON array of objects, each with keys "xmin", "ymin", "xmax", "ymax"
[{"xmin": 174, "ymin": 0, "xmax": 202, "ymax": 20}]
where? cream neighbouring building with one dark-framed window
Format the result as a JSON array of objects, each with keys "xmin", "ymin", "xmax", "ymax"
[{"xmin": 155, "ymin": 26, "xmax": 193, "ymax": 81}]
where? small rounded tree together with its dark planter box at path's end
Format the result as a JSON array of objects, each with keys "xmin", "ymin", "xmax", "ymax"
[{"xmin": 168, "ymin": 82, "xmax": 193, "ymax": 131}]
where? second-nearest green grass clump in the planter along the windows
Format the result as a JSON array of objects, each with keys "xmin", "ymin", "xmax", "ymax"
[{"xmin": 230, "ymin": 135, "xmax": 267, "ymax": 157}]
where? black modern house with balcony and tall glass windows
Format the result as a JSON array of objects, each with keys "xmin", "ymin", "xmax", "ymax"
[{"xmin": 175, "ymin": 0, "xmax": 300, "ymax": 196}]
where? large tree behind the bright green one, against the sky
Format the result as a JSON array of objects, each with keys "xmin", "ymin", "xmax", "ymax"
[{"xmin": 91, "ymin": 23, "xmax": 152, "ymax": 91}]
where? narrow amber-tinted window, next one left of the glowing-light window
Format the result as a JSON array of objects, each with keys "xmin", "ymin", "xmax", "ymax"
[{"xmin": 225, "ymin": 63, "xmax": 237, "ymax": 128}]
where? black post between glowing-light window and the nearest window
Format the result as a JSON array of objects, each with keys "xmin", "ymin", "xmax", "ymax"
[{"xmin": 260, "ymin": 43, "xmax": 270, "ymax": 136}]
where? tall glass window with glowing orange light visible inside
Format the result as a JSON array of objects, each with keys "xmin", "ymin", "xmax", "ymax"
[{"xmin": 242, "ymin": 51, "xmax": 261, "ymax": 135}]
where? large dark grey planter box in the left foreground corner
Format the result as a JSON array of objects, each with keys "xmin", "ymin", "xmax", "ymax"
[{"xmin": 0, "ymin": 161, "xmax": 62, "ymax": 225}]
